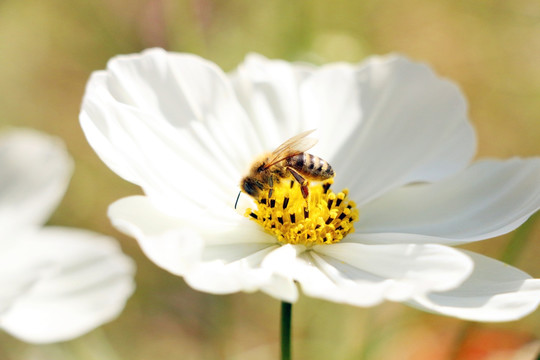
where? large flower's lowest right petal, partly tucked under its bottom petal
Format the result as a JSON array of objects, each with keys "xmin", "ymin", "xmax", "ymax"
[{"xmin": 411, "ymin": 252, "xmax": 540, "ymax": 322}]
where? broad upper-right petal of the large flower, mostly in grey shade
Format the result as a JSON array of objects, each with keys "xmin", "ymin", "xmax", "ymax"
[{"xmin": 302, "ymin": 56, "xmax": 475, "ymax": 204}]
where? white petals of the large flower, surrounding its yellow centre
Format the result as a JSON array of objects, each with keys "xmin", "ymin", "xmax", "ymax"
[{"xmin": 80, "ymin": 49, "xmax": 540, "ymax": 321}]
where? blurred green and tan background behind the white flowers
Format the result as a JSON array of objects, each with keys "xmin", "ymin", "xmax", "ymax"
[{"xmin": 0, "ymin": 0, "xmax": 540, "ymax": 360}]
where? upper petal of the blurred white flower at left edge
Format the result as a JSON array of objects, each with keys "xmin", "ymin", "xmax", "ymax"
[{"xmin": 0, "ymin": 130, "xmax": 73, "ymax": 236}]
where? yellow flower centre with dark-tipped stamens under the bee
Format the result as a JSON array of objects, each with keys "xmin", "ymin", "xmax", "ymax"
[{"xmin": 246, "ymin": 179, "xmax": 358, "ymax": 246}]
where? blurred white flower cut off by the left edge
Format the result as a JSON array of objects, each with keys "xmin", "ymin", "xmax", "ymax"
[{"xmin": 0, "ymin": 130, "xmax": 134, "ymax": 343}]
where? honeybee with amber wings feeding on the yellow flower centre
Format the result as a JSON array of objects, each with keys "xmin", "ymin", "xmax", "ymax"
[{"xmin": 240, "ymin": 130, "xmax": 334, "ymax": 200}]
